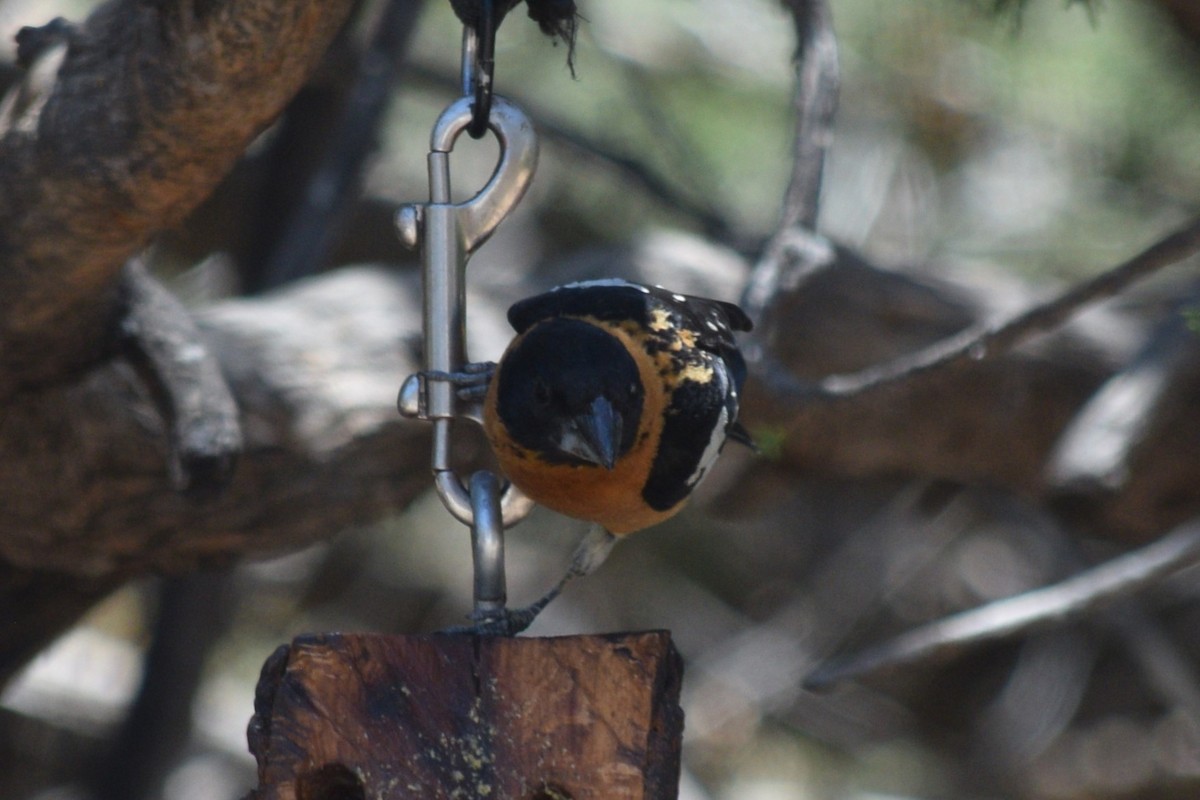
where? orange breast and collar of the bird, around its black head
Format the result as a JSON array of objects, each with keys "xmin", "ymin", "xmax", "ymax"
[{"xmin": 484, "ymin": 316, "xmax": 683, "ymax": 535}]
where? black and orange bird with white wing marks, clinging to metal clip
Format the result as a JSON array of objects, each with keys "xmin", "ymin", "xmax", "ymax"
[{"xmin": 472, "ymin": 278, "xmax": 754, "ymax": 624}]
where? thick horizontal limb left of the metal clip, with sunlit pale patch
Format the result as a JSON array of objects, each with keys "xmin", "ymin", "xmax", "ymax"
[{"xmin": 0, "ymin": 270, "xmax": 444, "ymax": 674}]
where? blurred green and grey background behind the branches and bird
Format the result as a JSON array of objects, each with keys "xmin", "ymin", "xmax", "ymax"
[{"xmin": 0, "ymin": 0, "xmax": 1200, "ymax": 800}]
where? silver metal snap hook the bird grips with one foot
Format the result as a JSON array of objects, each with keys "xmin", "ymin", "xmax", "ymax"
[{"xmin": 396, "ymin": 97, "xmax": 538, "ymax": 528}]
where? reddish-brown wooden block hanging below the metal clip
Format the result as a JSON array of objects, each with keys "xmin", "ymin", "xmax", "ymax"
[{"xmin": 247, "ymin": 631, "xmax": 683, "ymax": 800}]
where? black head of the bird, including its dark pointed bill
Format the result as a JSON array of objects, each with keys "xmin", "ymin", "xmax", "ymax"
[{"xmin": 496, "ymin": 318, "xmax": 644, "ymax": 469}]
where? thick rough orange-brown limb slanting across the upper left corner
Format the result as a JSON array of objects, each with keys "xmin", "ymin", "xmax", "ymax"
[{"xmin": 0, "ymin": 0, "xmax": 353, "ymax": 395}]
